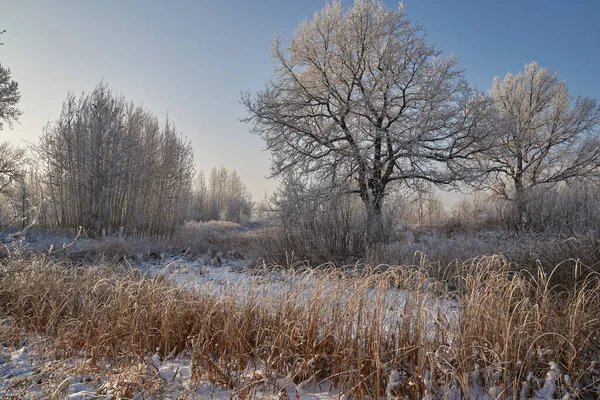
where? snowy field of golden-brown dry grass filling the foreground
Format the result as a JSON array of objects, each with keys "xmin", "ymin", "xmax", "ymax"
[{"xmin": 0, "ymin": 223, "xmax": 600, "ymax": 399}]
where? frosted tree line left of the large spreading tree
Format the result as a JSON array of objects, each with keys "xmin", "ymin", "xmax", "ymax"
[{"xmin": 0, "ymin": 31, "xmax": 253, "ymax": 237}]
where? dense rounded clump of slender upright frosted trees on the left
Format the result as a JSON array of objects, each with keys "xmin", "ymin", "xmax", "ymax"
[{"xmin": 38, "ymin": 84, "xmax": 194, "ymax": 237}]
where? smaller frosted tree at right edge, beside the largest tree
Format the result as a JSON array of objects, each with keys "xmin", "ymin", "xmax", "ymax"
[{"xmin": 479, "ymin": 63, "xmax": 600, "ymax": 227}]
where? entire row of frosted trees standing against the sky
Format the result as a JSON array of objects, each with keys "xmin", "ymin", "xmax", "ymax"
[{"xmin": 0, "ymin": 0, "xmax": 600, "ymax": 242}]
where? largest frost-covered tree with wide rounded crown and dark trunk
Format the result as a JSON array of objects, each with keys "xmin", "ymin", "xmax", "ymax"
[{"xmin": 242, "ymin": 0, "xmax": 487, "ymax": 239}]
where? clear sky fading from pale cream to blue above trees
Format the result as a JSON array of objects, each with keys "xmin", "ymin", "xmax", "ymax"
[{"xmin": 0, "ymin": 0, "xmax": 600, "ymax": 199}]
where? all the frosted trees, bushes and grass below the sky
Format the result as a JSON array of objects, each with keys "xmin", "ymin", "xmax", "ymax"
[{"xmin": 0, "ymin": 0, "xmax": 600, "ymax": 400}]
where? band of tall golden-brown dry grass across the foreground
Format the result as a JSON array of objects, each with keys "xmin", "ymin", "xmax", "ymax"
[{"xmin": 0, "ymin": 257, "xmax": 600, "ymax": 399}]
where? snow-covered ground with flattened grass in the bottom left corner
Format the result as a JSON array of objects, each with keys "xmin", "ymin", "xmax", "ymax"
[{"xmin": 0, "ymin": 336, "xmax": 340, "ymax": 400}]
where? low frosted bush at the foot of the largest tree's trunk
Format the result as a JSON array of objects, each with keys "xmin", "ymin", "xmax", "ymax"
[{"xmin": 260, "ymin": 173, "xmax": 369, "ymax": 264}]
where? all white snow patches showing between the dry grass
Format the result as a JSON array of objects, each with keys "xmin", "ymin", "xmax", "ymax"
[{"xmin": 0, "ymin": 234, "xmax": 600, "ymax": 400}]
